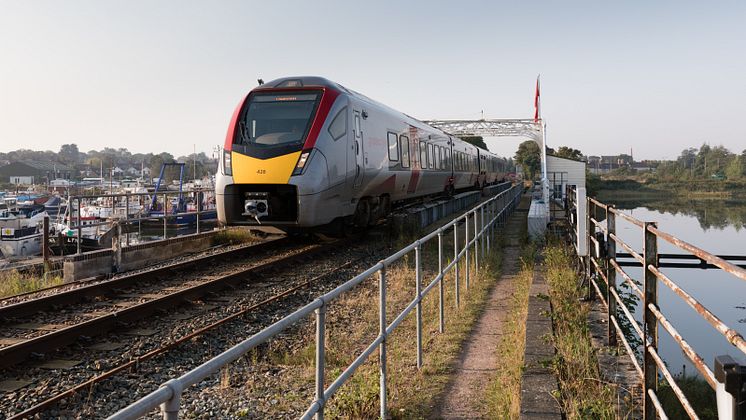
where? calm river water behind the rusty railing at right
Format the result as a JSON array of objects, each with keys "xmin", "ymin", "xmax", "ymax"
[{"xmin": 607, "ymin": 199, "xmax": 746, "ymax": 375}]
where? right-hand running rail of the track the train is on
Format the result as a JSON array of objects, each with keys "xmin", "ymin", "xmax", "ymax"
[{"xmin": 0, "ymin": 242, "xmax": 337, "ymax": 368}]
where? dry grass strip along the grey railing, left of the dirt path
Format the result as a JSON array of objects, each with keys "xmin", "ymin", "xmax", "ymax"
[{"xmin": 244, "ymin": 221, "xmax": 501, "ymax": 419}]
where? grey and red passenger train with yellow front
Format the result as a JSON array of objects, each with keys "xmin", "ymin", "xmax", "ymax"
[{"xmin": 215, "ymin": 77, "xmax": 508, "ymax": 232}]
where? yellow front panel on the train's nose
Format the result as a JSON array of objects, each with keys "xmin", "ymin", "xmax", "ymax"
[{"xmin": 231, "ymin": 152, "xmax": 300, "ymax": 184}]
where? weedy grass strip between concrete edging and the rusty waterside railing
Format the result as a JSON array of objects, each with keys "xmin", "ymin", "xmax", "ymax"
[{"xmin": 544, "ymin": 244, "xmax": 617, "ymax": 419}]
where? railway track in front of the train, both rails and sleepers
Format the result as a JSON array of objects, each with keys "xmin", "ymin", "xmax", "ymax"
[{"xmin": 0, "ymin": 239, "xmax": 331, "ymax": 368}]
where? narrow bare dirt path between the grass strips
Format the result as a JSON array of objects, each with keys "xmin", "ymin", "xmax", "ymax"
[{"xmin": 434, "ymin": 208, "xmax": 526, "ymax": 419}]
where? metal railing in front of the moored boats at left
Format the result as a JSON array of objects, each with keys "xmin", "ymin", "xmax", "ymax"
[{"xmin": 60, "ymin": 189, "xmax": 215, "ymax": 254}]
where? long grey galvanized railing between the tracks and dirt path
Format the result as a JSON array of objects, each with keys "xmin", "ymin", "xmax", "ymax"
[{"xmin": 110, "ymin": 185, "xmax": 522, "ymax": 419}]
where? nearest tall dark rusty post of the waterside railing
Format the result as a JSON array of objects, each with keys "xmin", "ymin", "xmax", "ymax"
[{"xmin": 642, "ymin": 222, "xmax": 658, "ymax": 419}]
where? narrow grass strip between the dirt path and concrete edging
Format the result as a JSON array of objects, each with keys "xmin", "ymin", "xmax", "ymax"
[{"xmin": 487, "ymin": 241, "xmax": 536, "ymax": 419}]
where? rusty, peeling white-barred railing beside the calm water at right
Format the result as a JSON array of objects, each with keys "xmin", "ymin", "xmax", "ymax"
[{"xmin": 566, "ymin": 189, "xmax": 746, "ymax": 419}]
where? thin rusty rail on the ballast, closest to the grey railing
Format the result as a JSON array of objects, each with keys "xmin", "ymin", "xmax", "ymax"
[{"xmin": 8, "ymin": 258, "xmax": 362, "ymax": 420}]
